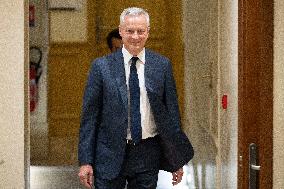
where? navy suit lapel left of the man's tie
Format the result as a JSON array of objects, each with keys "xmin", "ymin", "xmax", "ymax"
[{"xmin": 110, "ymin": 49, "xmax": 128, "ymax": 110}]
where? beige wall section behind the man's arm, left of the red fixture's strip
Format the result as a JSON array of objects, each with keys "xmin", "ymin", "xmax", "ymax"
[{"xmin": 183, "ymin": 0, "xmax": 220, "ymax": 188}]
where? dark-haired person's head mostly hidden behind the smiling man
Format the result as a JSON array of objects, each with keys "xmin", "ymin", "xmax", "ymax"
[{"xmin": 106, "ymin": 28, "xmax": 122, "ymax": 52}]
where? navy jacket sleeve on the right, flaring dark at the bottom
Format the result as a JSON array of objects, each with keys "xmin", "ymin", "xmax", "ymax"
[{"xmin": 160, "ymin": 62, "xmax": 194, "ymax": 172}]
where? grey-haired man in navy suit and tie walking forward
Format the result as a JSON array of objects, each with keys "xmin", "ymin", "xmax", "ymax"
[{"xmin": 78, "ymin": 7, "xmax": 193, "ymax": 189}]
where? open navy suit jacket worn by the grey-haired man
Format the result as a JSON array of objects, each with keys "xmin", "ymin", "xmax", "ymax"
[{"xmin": 78, "ymin": 49, "xmax": 193, "ymax": 179}]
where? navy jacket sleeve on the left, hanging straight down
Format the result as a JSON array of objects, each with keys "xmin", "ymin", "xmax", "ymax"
[{"xmin": 78, "ymin": 59, "xmax": 103, "ymax": 165}]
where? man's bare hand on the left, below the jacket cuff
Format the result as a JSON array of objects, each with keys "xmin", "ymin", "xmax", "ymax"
[{"xmin": 78, "ymin": 165, "xmax": 94, "ymax": 189}]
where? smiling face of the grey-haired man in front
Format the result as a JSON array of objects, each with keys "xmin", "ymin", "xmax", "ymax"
[{"xmin": 119, "ymin": 15, "xmax": 149, "ymax": 55}]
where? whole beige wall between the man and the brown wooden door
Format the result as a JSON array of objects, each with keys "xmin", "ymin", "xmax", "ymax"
[{"xmin": 183, "ymin": 0, "xmax": 238, "ymax": 188}]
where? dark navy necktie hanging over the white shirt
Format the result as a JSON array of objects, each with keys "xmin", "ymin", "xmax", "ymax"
[{"xmin": 129, "ymin": 57, "xmax": 142, "ymax": 143}]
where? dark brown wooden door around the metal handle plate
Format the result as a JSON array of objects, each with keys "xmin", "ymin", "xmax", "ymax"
[{"xmin": 238, "ymin": 0, "xmax": 274, "ymax": 188}]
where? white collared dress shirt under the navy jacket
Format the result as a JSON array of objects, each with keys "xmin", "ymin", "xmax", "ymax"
[{"xmin": 122, "ymin": 46, "xmax": 157, "ymax": 139}]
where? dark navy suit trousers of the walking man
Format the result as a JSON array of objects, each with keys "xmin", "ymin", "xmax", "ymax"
[{"xmin": 95, "ymin": 137, "xmax": 161, "ymax": 189}]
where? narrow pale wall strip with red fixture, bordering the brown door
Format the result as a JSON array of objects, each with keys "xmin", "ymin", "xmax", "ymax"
[{"xmin": 218, "ymin": 0, "xmax": 238, "ymax": 188}]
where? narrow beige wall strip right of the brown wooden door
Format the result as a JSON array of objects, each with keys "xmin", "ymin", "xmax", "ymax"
[{"xmin": 273, "ymin": 0, "xmax": 284, "ymax": 189}]
